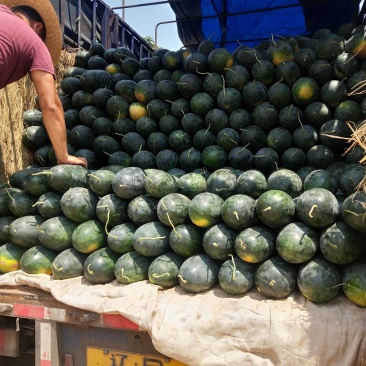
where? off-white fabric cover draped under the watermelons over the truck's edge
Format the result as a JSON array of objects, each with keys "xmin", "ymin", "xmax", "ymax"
[{"xmin": 0, "ymin": 271, "xmax": 366, "ymax": 366}]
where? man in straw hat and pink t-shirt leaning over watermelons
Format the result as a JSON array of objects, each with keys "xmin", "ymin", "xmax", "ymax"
[{"xmin": 0, "ymin": 0, "xmax": 87, "ymax": 167}]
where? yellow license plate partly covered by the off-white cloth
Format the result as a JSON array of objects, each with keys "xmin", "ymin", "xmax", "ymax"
[{"xmin": 86, "ymin": 347, "xmax": 185, "ymax": 366}]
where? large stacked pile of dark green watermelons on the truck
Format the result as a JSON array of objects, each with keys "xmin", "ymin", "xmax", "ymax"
[{"xmin": 0, "ymin": 24, "xmax": 366, "ymax": 306}]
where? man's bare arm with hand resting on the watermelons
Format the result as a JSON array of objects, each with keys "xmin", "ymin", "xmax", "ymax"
[{"xmin": 30, "ymin": 70, "xmax": 87, "ymax": 167}]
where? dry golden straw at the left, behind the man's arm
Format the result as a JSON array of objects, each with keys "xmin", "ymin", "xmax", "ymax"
[{"xmin": 0, "ymin": 50, "xmax": 75, "ymax": 182}]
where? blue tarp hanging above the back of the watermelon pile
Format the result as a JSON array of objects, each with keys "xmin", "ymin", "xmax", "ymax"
[{"xmin": 170, "ymin": 0, "xmax": 361, "ymax": 51}]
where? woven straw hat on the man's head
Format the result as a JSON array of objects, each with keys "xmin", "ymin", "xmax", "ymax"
[{"xmin": 0, "ymin": 0, "xmax": 62, "ymax": 65}]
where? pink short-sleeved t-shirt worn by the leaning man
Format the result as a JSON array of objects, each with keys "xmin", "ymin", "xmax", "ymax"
[{"xmin": 0, "ymin": 5, "xmax": 55, "ymax": 89}]
